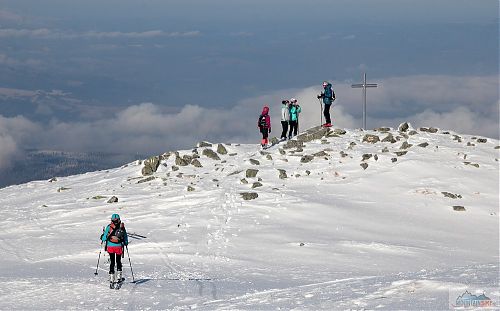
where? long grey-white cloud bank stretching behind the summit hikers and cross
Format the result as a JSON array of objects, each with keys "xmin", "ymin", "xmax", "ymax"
[{"xmin": 0, "ymin": 76, "xmax": 500, "ymax": 167}]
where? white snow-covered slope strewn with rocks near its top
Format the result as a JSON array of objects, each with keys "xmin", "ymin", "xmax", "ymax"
[{"xmin": 0, "ymin": 128, "xmax": 499, "ymax": 310}]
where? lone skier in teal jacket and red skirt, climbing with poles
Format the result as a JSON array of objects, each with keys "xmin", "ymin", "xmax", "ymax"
[{"xmin": 101, "ymin": 214, "xmax": 128, "ymax": 283}]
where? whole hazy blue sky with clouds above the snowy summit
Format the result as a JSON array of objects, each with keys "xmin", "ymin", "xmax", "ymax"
[{"xmin": 0, "ymin": 0, "xmax": 499, "ymax": 167}]
